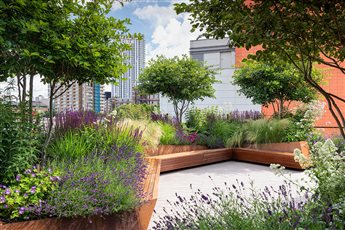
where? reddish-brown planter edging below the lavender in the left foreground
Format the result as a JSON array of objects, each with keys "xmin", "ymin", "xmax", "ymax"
[{"xmin": 0, "ymin": 159, "xmax": 160, "ymax": 230}]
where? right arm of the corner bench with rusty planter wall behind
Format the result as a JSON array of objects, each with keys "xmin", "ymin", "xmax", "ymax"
[{"xmin": 232, "ymin": 142, "xmax": 309, "ymax": 169}]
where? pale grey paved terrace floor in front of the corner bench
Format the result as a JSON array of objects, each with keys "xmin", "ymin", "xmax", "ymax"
[{"xmin": 149, "ymin": 161, "xmax": 307, "ymax": 229}]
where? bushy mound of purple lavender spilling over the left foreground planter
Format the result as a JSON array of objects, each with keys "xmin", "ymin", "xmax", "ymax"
[{"xmin": 42, "ymin": 145, "xmax": 147, "ymax": 217}]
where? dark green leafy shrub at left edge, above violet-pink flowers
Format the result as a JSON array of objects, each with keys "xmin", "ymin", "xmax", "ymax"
[{"xmin": 0, "ymin": 101, "xmax": 42, "ymax": 183}]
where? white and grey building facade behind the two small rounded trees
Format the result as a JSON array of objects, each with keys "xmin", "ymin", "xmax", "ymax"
[{"xmin": 160, "ymin": 39, "xmax": 261, "ymax": 115}]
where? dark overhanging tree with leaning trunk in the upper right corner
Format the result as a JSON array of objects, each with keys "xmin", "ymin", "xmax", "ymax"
[{"xmin": 175, "ymin": 0, "xmax": 345, "ymax": 138}]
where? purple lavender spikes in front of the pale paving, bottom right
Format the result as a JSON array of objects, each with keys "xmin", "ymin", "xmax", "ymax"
[{"xmin": 153, "ymin": 181, "xmax": 318, "ymax": 230}]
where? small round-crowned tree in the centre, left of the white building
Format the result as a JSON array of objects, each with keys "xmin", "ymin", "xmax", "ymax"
[{"xmin": 138, "ymin": 55, "xmax": 217, "ymax": 123}]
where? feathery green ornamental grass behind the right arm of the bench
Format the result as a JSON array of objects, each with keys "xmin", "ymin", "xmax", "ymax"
[{"xmin": 227, "ymin": 119, "xmax": 290, "ymax": 147}]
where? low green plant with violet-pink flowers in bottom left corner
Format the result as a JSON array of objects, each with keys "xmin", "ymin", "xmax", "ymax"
[{"xmin": 0, "ymin": 168, "xmax": 60, "ymax": 221}]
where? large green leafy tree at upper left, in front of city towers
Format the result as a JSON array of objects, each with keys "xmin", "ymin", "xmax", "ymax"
[{"xmin": 0, "ymin": 0, "xmax": 140, "ymax": 158}]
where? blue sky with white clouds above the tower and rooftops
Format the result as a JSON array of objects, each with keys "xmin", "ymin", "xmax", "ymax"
[{"xmin": 0, "ymin": 0, "xmax": 200, "ymax": 97}]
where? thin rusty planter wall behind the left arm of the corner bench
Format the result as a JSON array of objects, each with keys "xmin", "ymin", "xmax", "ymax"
[{"xmin": 145, "ymin": 145, "xmax": 208, "ymax": 156}]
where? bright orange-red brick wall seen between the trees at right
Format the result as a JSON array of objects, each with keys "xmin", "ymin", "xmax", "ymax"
[{"xmin": 235, "ymin": 47, "xmax": 345, "ymax": 135}]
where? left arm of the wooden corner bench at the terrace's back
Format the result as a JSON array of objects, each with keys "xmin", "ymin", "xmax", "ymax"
[{"xmin": 148, "ymin": 148, "xmax": 232, "ymax": 172}]
